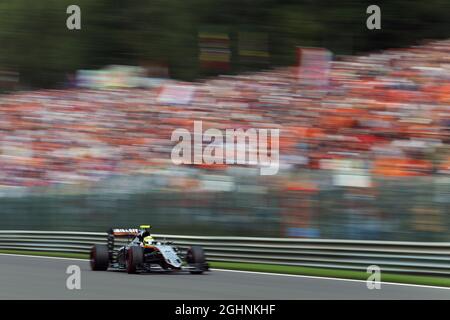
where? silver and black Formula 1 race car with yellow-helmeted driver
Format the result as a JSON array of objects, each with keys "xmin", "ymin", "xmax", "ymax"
[{"xmin": 90, "ymin": 225, "xmax": 209, "ymax": 274}]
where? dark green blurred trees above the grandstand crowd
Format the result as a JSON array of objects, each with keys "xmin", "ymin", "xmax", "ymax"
[{"xmin": 0, "ymin": 0, "xmax": 450, "ymax": 87}]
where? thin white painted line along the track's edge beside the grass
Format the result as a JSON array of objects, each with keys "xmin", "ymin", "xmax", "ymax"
[{"xmin": 0, "ymin": 253, "xmax": 450, "ymax": 290}]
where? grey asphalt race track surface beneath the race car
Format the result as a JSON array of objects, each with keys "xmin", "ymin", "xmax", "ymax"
[{"xmin": 0, "ymin": 254, "xmax": 450, "ymax": 300}]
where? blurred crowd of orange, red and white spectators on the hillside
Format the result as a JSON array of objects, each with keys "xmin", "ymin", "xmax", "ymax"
[{"xmin": 0, "ymin": 40, "xmax": 450, "ymax": 236}]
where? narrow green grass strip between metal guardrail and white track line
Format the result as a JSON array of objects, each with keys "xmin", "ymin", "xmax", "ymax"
[{"xmin": 0, "ymin": 250, "xmax": 450, "ymax": 287}]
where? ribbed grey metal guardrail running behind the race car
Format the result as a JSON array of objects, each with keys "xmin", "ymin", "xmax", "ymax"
[{"xmin": 0, "ymin": 230, "xmax": 450, "ymax": 276}]
